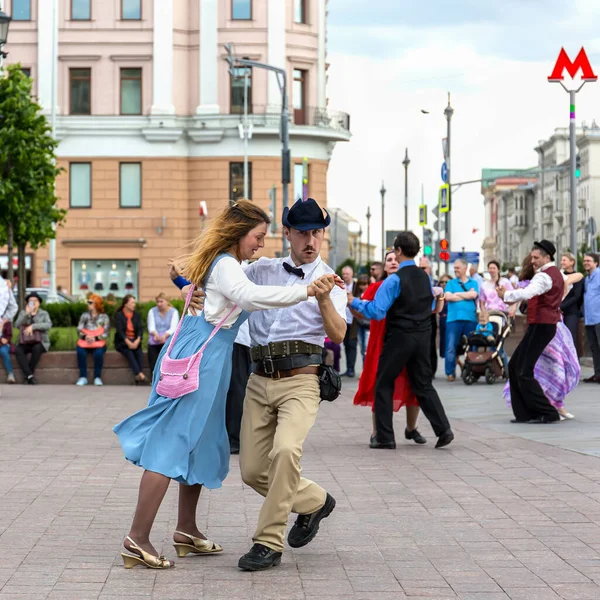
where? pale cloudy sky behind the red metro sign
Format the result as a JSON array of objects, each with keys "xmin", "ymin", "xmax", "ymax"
[{"xmin": 327, "ymin": 0, "xmax": 600, "ymax": 255}]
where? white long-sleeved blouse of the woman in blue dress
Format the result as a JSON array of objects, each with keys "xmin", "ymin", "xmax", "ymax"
[{"xmin": 204, "ymin": 256, "xmax": 308, "ymax": 329}]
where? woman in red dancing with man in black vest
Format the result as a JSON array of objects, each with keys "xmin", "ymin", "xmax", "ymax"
[{"xmin": 354, "ymin": 251, "xmax": 427, "ymax": 444}]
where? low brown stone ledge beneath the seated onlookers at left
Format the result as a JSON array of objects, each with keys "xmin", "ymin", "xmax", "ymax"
[{"xmin": 0, "ymin": 350, "xmax": 151, "ymax": 385}]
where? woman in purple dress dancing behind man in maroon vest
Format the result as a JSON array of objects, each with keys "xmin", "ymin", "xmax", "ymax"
[{"xmin": 504, "ymin": 255, "xmax": 583, "ymax": 421}]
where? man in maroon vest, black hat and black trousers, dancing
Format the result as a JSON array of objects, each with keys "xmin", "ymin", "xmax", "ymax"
[{"xmin": 496, "ymin": 240, "xmax": 564, "ymax": 423}]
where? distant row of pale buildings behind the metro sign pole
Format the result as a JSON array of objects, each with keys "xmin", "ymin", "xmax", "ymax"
[{"xmin": 482, "ymin": 122, "xmax": 600, "ymax": 263}]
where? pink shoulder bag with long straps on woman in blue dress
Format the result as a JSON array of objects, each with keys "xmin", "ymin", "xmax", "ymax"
[{"xmin": 156, "ymin": 285, "xmax": 237, "ymax": 400}]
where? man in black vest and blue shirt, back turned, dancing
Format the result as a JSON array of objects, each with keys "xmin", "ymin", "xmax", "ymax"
[{"xmin": 350, "ymin": 231, "xmax": 454, "ymax": 449}]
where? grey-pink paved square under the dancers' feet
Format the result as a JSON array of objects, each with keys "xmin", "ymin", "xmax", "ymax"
[{"xmin": 0, "ymin": 381, "xmax": 600, "ymax": 600}]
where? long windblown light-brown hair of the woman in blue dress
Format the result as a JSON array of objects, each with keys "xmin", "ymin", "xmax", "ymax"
[{"xmin": 182, "ymin": 200, "xmax": 271, "ymax": 286}]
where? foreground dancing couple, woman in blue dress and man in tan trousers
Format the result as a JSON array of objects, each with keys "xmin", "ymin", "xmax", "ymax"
[{"xmin": 114, "ymin": 199, "xmax": 346, "ymax": 571}]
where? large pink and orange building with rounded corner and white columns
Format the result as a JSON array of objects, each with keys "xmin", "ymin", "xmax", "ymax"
[{"xmin": 0, "ymin": 0, "xmax": 350, "ymax": 300}]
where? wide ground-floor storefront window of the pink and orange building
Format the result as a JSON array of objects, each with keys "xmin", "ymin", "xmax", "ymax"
[{"xmin": 71, "ymin": 260, "xmax": 139, "ymax": 298}]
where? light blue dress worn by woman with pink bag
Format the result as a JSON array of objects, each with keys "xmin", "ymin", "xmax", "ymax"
[{"xmin": 113, "ymin": 255, "xmax": 249, "ymax": 489}]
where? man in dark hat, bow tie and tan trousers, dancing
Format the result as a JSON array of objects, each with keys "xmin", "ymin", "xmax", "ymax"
[{"xmin": 173, "ymin": 198, "xmax": 347, "ymax": 571}]
